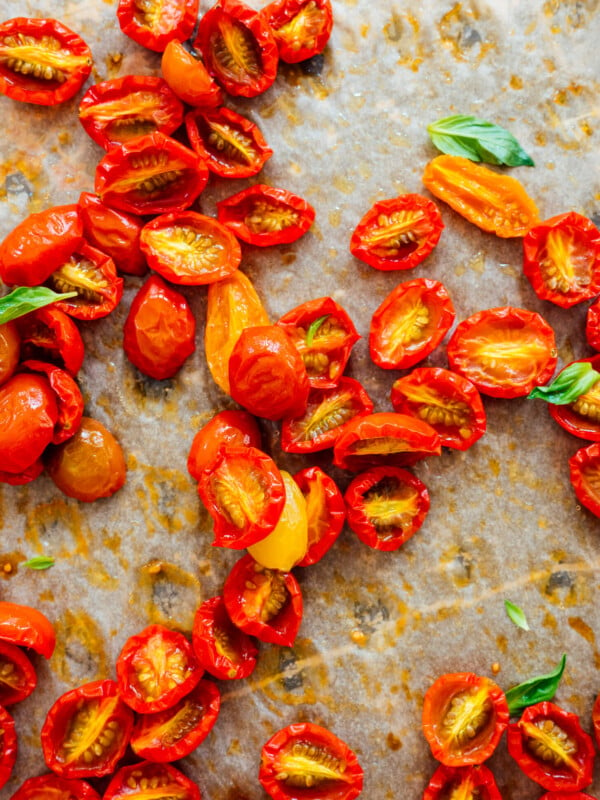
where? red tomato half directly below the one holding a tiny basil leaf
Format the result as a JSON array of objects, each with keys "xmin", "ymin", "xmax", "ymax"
[{"xmin": 281, "ymin": 377, "xmax": 373, "ymax": 453}]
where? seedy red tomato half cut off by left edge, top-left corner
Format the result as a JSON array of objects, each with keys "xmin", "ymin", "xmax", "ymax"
[{"xmin": 0, "ymin": 17, "xmax": 92, "ymax": 106}]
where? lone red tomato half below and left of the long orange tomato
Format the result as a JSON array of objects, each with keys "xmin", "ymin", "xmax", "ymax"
[{"xmin": 350, "ymin": 194, "xmax": 444, "ymax": 271}]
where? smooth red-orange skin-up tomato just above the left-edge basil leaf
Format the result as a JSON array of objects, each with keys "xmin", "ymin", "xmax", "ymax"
[{"xmin": 0, "ymin": 204, "xmax": 84, "ymax": 286}]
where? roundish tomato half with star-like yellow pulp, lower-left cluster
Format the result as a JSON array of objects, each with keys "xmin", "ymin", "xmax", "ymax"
[{"xmin": 116, "ymin": 625, "xmax": 204, "ymax": 714}]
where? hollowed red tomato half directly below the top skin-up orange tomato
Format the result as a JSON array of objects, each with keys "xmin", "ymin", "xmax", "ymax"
[{"xmin": 185, "ymin": 107, "xmax": 273, "ymax": 178}]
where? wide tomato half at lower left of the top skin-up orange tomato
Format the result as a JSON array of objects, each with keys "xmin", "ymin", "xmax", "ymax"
[{"xmin": 79, "ymin": 75, "xmax": 184, "ymax": 150}]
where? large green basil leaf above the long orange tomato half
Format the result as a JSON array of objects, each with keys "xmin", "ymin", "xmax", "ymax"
[{"xmin": 427, "ymin": 114, "xmax": 535, "ymax": 167}]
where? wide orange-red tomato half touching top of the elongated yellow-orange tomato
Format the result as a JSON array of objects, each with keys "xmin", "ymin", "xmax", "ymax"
[{"xmin": 141, "ymin": 211, "xmax": 242, "ymax": 286}]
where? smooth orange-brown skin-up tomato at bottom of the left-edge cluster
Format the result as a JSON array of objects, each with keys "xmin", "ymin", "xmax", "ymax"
[{"xmin": 44, "ymin": 417, "xmax": 127, "ymax": 503}]
